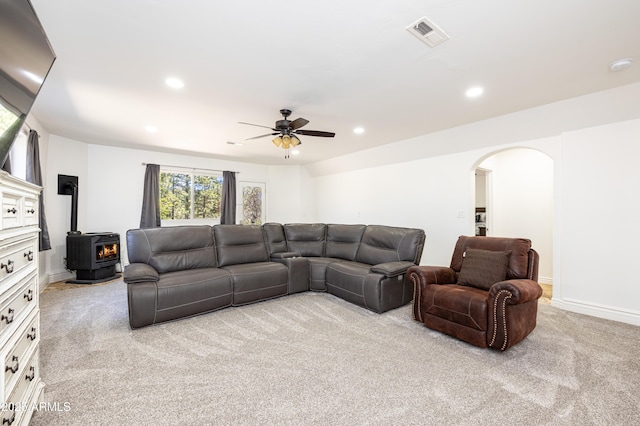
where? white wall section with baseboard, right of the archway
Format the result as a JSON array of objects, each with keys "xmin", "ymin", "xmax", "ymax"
[{"xmin": 557, "ymin": 119, "xmax": 640, "ymax": 325}]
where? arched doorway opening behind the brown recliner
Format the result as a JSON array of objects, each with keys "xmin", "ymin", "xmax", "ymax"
[{"xmin": 474, "ymin": 148, "xmax": 553, "ymax": 285}]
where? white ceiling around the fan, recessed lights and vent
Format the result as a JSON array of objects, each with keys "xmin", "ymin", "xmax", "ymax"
[{"xmin": 27, "ymin": 0, "xmax": 640, "ymax": 164}]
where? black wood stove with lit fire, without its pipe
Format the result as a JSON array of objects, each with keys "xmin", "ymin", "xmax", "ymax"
[{"xmin": 67, "ymin": 232, "xmax": 120, "ymax": 282}]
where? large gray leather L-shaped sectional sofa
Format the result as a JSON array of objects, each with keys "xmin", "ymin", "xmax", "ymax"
[{"xmin": 124, "ymin": 223, "xmax": 425, "ymax": 328}]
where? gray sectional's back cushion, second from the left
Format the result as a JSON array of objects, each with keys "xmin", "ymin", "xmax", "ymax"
[{"xmin": 213, "ymin": 225, "xmax": 269, "ymax": 267}]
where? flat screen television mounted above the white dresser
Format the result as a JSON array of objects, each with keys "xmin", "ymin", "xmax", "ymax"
[{"xmin": 0, "ymin": 0, "xmax": 56, "ymax": 167}]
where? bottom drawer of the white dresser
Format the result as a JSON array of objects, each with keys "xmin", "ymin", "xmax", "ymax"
[{"xmin": 2, "ymin": 352, "xmax": 40, "ymax": 425}]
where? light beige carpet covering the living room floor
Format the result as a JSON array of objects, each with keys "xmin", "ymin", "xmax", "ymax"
[{"xmin": 31, "ymin": 281, "xmax": 640, "ymax": 426}]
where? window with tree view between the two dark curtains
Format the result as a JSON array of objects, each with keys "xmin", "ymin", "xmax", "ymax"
[{"xmin": 160, "ymin": 170, "xmax": 222, "ymax": 223}]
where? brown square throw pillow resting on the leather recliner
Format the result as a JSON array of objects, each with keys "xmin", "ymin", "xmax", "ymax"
[{"xmin": 458, "ymin": 249, "xmax": 511, "ymax": 290}]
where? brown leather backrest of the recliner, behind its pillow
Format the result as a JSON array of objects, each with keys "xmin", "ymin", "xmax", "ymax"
[{"xmin": 451, "ymin": 235, "xmax": 537, "ymax": 279}]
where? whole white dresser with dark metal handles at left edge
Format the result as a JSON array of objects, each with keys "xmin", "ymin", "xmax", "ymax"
[{"xmin": 0, "ymin": 171, "xmax": 44, "ymax": 426}]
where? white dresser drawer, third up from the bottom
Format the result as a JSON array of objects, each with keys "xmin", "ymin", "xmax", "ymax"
[{"xmin": 0, "ymin": 274, "xmax": 38, "ymax": 335}]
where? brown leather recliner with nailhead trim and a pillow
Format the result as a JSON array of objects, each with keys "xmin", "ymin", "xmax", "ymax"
[{"xmin": 407, "ymin": 236, "xmax": 542, "ymax": 351}]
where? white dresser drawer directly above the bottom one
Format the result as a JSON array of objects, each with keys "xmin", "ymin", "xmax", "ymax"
[{"xmin": 3, "ymin": 313, "xmax": 40, "ymax": 395}]
